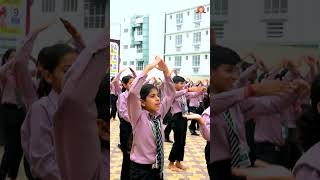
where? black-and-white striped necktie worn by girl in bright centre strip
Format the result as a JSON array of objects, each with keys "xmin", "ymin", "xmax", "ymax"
[{"xmin": 151, "ymin": 116, "xmax": 164, "ymax": 177}]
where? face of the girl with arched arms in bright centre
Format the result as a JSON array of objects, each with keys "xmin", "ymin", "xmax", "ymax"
[{"xmin": 141, "ymin": 89, "xmax": 160, "ymax": 113}]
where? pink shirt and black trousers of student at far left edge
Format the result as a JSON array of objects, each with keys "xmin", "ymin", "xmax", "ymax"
[{"xmin": 0, "ymin": 33, "xmax": 38, "ymax": 179}]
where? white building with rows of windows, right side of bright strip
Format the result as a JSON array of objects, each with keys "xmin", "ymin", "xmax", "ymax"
[{"xmin": 164, "ymin": 4, "xmax": 210, "ymax": 76}]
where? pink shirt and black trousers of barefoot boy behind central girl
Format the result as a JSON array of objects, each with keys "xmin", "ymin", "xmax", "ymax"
[{"xmin": 169, "ymin": 89, "xmax": 202, "ymax": 162}]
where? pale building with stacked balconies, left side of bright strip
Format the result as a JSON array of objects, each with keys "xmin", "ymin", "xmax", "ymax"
[{"xmin": 120, "ymin": 15, "xmax": 149, "ymax": 71}]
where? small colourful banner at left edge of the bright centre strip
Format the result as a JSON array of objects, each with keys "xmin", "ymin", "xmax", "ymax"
[{"xmin": 110, "ymin": 39, "xmax": 120, "ymax": 77}]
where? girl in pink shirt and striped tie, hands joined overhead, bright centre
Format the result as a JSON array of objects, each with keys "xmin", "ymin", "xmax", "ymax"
[{"xmin": 127, "ymin": 57, "xmax": 175, "ymax": 180}]
